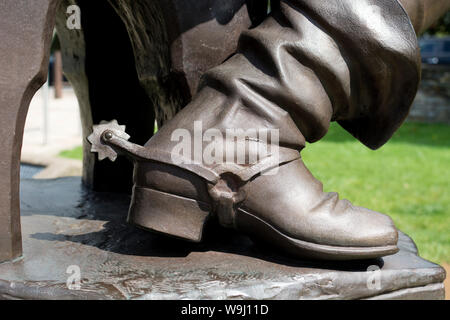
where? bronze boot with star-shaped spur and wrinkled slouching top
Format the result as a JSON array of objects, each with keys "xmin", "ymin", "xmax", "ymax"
[{"xmin": 90, "ymin": 0, "xmax": 420, "ymax": 260}]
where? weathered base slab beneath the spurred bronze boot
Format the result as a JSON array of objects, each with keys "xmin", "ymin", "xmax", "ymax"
[{"xmin": 0, "ymin": 178, "xmax": 445, "ymax": 300}]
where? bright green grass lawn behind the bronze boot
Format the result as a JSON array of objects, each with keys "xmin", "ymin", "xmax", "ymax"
[{"xmin": 61, "ymin": 123, "xmax": 450, "ymax": 263}]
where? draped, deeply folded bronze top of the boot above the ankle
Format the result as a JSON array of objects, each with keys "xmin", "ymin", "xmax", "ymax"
[{"xmin": 202, "ymin": 0, "xmax": 420, "ymax": 149}]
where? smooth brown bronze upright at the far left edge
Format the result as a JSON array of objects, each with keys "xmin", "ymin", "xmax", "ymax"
[{"xmin": 0, "ymin": 0, "xmax": 59, "ymax": 262}]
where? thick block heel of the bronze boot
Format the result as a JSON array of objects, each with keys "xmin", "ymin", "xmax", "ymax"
[{"xmin": 128, "ymin": 187, "xmax": 211, "ymax": 242}]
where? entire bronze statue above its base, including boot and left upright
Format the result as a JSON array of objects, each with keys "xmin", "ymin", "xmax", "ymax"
[{"xmin": 0, "ymin": 0, "xmax": 450, "ymax": 262}]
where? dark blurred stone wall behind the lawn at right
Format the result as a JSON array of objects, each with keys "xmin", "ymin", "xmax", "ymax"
[{"xmin": 408, "ymin": 65, "xmax": 450, "ymax": 124}]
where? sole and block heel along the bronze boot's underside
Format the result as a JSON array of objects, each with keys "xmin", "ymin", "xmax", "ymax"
[{"xmin": 128, "ymin": 187, "xmax": 399, "ymax": 260}]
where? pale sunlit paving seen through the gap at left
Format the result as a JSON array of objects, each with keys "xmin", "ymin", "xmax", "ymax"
[{"xmin": 21, "ymin": 87, "xmax": 82, "ymax": 178}]
